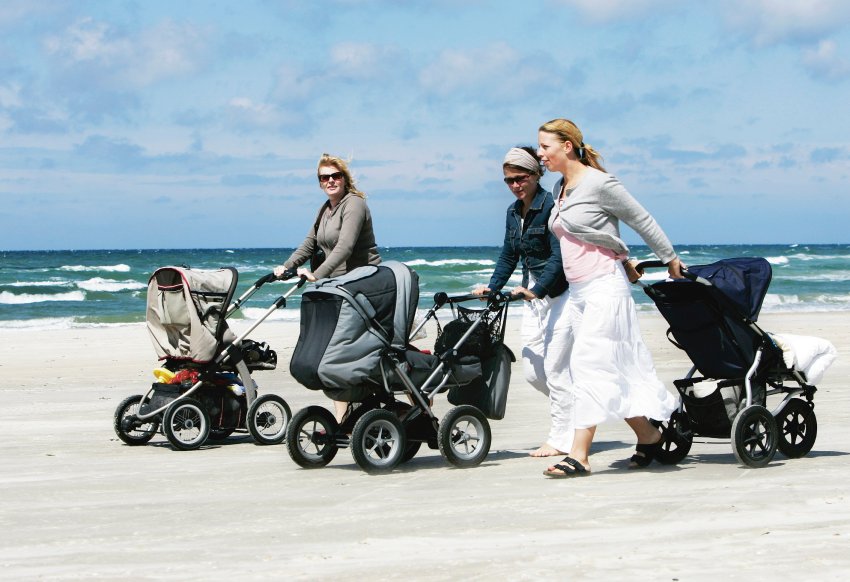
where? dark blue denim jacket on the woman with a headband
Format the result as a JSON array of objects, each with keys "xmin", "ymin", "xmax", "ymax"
[{"xmin": 489, "ymin": 186, "xmax": 567, "ymax": 298}]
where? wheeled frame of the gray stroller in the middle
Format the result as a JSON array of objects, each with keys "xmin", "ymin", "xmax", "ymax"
[{"xmin": 286, "ymin": 293, "xmax": 517, "ymax": 474}]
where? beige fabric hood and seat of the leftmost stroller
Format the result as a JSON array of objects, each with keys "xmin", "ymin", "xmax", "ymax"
[{"xmin": 146, "ymin": 267, "xmax": 238, "ymax": 363}]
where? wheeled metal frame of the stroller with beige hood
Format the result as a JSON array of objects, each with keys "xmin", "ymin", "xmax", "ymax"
[{"xmin": 114, "ymin": 267, "xmax": 306, "ymax": 450}]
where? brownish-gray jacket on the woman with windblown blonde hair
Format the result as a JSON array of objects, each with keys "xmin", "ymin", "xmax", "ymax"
[{"xmin": 283, "ymin": 194, "xmax": 381, "ymax": 279}]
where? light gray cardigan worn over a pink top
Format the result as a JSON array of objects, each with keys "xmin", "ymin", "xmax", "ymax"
[{"xmin": 553, "ymin": 166, "xmax": 676, "ymax": 263}]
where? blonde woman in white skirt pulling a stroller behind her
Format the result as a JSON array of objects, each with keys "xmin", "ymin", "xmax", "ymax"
[{"xmin": 538, "ymin": 119, "xmax": 682, "ymax": 478}]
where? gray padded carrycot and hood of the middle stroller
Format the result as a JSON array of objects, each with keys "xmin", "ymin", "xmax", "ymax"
[{"xmin": 289, "ymin": 261, "xmax": 419, "ymax": 399}]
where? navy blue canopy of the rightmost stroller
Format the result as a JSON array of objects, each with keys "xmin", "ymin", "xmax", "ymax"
[{"xmin": 688, "ymin": 257, "xmax": 772, "ymax": 321}]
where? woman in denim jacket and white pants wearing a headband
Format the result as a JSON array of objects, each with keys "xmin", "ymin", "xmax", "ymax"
[{"xmin": 473, "ymin": 146, "xmax": 575, "ymax": 457}]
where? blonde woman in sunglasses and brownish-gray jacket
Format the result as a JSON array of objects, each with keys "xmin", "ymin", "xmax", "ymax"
[{"xmin": 274, "ymin": 154, "xmax": 381, "ymax": 281}]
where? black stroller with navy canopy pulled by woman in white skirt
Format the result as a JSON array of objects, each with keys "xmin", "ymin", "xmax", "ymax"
[{"xmin": 637, "ymin": 258, "xmax": 818, "ymax": 467}]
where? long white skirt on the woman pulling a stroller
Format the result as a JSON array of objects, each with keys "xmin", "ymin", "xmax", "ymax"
[{"xmin": 561, "ymin": 263, "xmax": 679, "ymax": 428}]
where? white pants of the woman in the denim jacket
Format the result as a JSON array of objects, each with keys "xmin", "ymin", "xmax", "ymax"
[{"xmin": 521, "ymin": 292, "xmax": 575, "ymax": 452}]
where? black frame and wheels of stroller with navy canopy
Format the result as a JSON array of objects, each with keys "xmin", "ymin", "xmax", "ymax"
[{"xmin": 637, "ymin": 259, "xmax": 817, "ymax": 468}]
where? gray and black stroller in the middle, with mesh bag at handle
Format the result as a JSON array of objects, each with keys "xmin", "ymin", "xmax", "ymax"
[{"xmin": 286, "ymin": 261, "xmax": 515, "ymax": 473}]
